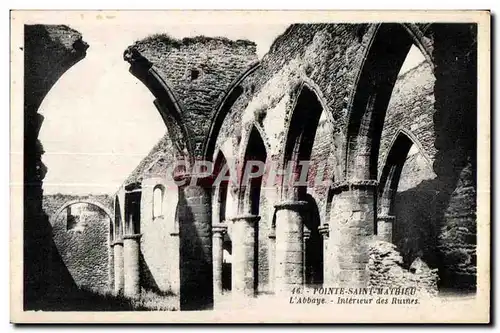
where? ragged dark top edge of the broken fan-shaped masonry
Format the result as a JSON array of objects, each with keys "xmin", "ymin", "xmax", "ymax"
[{"xmin": 132, "ymin": 33, "xmax": 257, "ymax": 48}]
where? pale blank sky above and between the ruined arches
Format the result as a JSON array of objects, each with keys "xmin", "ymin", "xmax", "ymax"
[{"xmin": 40, "ymin": 17, "xmax": 423, "ymax": 194}]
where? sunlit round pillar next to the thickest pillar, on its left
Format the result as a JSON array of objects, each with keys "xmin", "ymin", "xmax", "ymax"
[{"xmin": 274, "ymin": 201, "xmax": 307, "ymax": 294}]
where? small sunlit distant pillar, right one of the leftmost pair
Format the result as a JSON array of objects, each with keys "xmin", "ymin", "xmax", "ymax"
[{"xmin": 123, "ymin": 234, "xmax": 141, "ymax": 298}]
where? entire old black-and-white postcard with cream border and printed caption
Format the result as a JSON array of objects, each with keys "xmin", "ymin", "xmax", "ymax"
[{"xmin": 10, "ymin": 11, "xmax": 491, "ymax": 323}]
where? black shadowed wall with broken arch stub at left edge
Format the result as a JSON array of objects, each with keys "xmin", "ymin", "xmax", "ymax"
[{"xmin": 23, "ymin": 25, "xmax": 88, "ymax": 309}]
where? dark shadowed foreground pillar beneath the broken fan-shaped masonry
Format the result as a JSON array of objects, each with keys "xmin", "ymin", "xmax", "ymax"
[{"xmin": 174, "ymin": 174, "xmax": 214, "ymax": 310}]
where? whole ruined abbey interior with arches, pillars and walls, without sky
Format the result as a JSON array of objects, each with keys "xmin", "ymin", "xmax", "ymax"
[{"xmin": 24, "ymin": 23, "xmax": 477, "ymax": 310}]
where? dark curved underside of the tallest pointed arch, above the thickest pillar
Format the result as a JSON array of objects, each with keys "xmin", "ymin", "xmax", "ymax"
[{"xmin": 344, "ymin": 23, "xmax": 433, "ymax": 180}]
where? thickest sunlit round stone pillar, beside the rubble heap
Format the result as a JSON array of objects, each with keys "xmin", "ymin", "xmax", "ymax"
[{"xmin": 328, "ymin": 180, "xmax": 378, "ymax": 287}]
